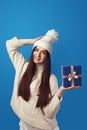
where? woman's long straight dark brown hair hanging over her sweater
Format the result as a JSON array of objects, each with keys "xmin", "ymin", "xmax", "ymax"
[{"xmin": 18, "ymin": 48, "xmax": 51, "ymax": 109}]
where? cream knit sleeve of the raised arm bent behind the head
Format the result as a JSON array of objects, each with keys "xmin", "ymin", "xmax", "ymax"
[{"xmin": 6, "ymin": 37, "xmax": 26, "ymax": 70}]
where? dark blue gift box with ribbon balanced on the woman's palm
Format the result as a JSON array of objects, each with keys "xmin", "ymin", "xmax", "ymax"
[{"xmin": 62, "ymin": 65, "xmax": 82, "ymax": 87}]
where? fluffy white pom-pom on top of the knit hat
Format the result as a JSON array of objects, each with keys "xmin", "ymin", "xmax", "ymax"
[{"xmin": 46, "ymin": 29, "xmax": 58, "ymax": 43}]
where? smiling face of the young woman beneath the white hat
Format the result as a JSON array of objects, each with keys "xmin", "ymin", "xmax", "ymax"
[{"xmin": 33, "ymin": 46, "xmax": 47, "ymax": 64}]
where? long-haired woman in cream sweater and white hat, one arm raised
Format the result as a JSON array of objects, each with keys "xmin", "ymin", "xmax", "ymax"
[{"xmin": 6, "ymin": 29, "xmax": 79, "ymax": 130}]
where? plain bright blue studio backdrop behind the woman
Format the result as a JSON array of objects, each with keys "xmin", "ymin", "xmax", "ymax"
[{"xmin": 0, "ymin": 0, "xmax": 87, "ymax": 130}]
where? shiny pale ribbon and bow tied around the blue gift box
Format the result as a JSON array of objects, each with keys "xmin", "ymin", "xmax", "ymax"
[{"xmin": 63, "ymin": 66, "xmax": 81, "ymax": 86}]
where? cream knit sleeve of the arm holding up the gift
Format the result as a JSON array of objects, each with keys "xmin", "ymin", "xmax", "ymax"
[{"xmin": 44, "ymin": 75, "xmax": 61, "ymax": 118}]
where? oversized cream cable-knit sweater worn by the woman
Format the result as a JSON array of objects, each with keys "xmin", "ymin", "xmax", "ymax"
[{"xmin": 6, "ymin": 37, "xmax": 60, "ymax": 130}]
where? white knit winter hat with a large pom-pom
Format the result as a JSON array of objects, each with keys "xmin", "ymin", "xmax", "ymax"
[{"xmin": 33, "ymin": 29, "xmax": 58, "ymax": 54}]
